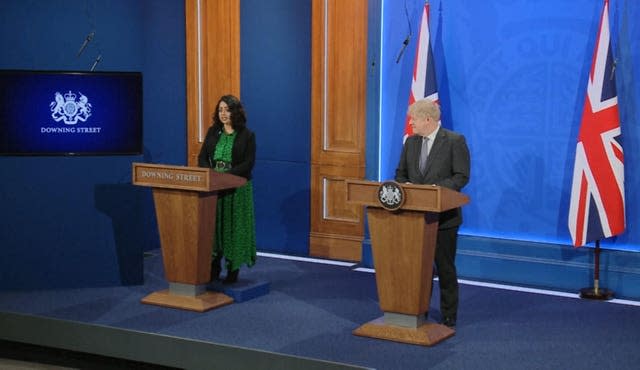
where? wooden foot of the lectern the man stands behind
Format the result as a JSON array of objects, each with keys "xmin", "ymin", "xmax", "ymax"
[{"xmin": 353, "ymin": 317, "xmax": 456, "ymax": 346}]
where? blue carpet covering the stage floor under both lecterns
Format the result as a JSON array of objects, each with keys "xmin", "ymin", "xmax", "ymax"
[{"xmin": 0, "ymin": 252, "xmax": 640, "ymax": 369}]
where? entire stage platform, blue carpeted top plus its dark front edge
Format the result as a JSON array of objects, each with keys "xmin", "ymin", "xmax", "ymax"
[{"xmin": 0, "ymin": 251, "xmax": 640, "ymax": 369}]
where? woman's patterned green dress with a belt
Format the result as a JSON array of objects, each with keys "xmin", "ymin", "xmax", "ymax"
[{"xmin": 212, "ymin": 132, "xmax": 256, "ymax": 271}]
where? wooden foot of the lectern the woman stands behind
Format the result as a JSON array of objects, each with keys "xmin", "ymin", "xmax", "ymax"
[{"xmin": 141, "ymin": 289, "xmax": 233, "ymax": 312}]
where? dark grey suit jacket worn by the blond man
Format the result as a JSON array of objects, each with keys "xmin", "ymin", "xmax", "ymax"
[{"xmin": 395, "ymin": 127, "xmax": 470, "ymax": 229}]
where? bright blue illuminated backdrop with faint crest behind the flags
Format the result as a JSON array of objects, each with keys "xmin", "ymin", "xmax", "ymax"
[{"xmin": 380, "ymin": 0, "xmax": 640, "ymax": 250}]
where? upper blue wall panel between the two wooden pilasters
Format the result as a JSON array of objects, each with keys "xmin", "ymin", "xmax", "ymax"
[{"xmin": 241, "ymin": 0, "xmax": 311, "ymax": 158}]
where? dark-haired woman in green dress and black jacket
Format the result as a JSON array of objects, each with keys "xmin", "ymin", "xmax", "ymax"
[{"xmin": 198, "ymin": 95, "xmax": 256, "ymax": 284}]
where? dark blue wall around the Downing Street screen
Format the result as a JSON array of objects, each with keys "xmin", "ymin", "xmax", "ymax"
[{"xmin": 0, "ymin": 0, "xmax": 186, "ymax": 289}]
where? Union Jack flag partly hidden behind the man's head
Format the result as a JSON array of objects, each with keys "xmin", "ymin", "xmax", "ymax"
[{"xmin": 403, "ymin": 2, "xmax": 438, "ymax": 141}]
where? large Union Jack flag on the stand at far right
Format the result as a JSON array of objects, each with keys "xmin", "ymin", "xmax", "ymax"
[{"xmin": 569, "ymin": 0, "xmax": 625, "ymax": 247}]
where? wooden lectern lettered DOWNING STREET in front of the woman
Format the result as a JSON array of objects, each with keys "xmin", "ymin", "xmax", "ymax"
[{"xmin": 132, "ymin": 163, "xmax": 246, "ymax": 312}]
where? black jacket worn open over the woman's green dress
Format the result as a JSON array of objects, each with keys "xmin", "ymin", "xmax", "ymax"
[{"xmin": 198, "ymin": 125, "xmax": 256, "ymax": 180}]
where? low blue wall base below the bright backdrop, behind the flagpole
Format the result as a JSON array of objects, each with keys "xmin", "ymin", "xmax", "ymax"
[{"xmin": 456, "ymin": 236, "xmax": 640, "ymax": 299}]
